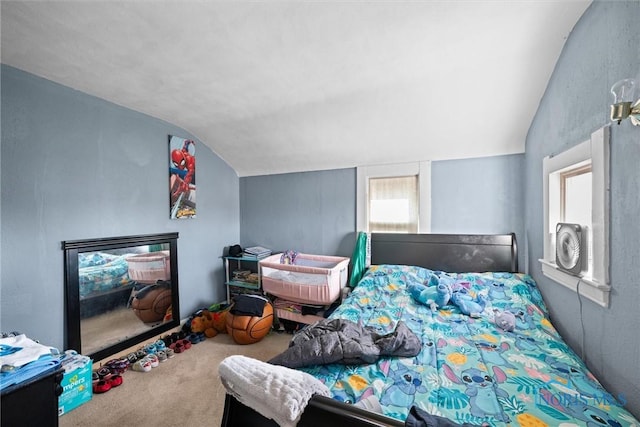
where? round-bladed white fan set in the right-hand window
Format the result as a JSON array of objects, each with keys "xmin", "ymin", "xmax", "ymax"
[{"xmin": 556, "ymin": 222, "xmax": 587, "ymax": 276}]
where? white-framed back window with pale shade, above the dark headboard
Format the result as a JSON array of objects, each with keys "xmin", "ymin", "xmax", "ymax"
[{"xmin": 357, "ymin": 162, "xmax": 431, "ymax": 233}]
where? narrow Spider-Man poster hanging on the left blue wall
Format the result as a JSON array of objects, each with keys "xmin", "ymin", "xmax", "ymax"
[{"xmin": 169, "ymin": 135, "xmax": 196, "ymax": 219}]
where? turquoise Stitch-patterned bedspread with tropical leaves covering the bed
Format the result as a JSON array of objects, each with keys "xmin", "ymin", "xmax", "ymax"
[{"xmin": 303, "ymin": 265, "xmax": 639, "ymax": 427}]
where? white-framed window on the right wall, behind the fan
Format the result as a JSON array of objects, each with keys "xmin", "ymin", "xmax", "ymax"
[{"xmin": 540, "ymin": 127, "xmax": 610, "ymax": 307}]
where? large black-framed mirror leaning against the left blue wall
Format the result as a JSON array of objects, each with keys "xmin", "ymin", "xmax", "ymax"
[{"xmin": 62, "ymin": 233, "xmax": 180, "ymax": 361}]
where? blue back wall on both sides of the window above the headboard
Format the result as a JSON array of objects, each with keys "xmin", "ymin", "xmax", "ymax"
[{"xmin": 240, "ymin": 154, "xmax": 524, "ymax": 262}]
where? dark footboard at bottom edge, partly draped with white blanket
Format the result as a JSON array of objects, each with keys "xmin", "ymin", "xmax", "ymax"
[{"xmin": 221, "ymin": 394, "xmax": 404, "ymax": 427}]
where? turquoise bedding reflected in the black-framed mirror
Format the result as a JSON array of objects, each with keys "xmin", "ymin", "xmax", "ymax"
[{"xmin": 78, "ymin": 252, "xmax": 131, "ymax": 298}]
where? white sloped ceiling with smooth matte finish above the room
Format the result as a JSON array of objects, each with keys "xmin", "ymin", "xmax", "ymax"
[{"xmin": 1, "ymin": 0, "xmax": 590, "ymax": 176}]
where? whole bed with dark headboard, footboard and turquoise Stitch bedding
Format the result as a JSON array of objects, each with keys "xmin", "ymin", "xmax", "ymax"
[{"xmin": 222, "ymin": 234, "xmax": 638, "ymax": 427}]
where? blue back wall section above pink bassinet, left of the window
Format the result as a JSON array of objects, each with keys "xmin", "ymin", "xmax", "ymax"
[{"xmin": 240, "ymin": 169, "xmax": 356, "ymax": 257}]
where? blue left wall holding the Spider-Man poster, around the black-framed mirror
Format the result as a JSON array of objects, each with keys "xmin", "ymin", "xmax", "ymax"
[{"xmin": 0, "ymin": 65, "xmax": 240, "ymax": 348}]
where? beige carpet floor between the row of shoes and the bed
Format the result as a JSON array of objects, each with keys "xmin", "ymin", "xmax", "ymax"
[{"xmin": 59, "ymin": 332, "xmax": 291, "ymax": 427}]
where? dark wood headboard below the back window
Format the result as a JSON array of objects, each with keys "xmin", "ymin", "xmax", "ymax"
[{"xmin": 371, "ymin": 233, "xmax": 518, "ymax": 273}]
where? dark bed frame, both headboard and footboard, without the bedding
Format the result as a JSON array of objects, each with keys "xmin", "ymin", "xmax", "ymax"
[{"xmin": 221, "ymin": 233, "xmax": 518, "ymax": 427}]
